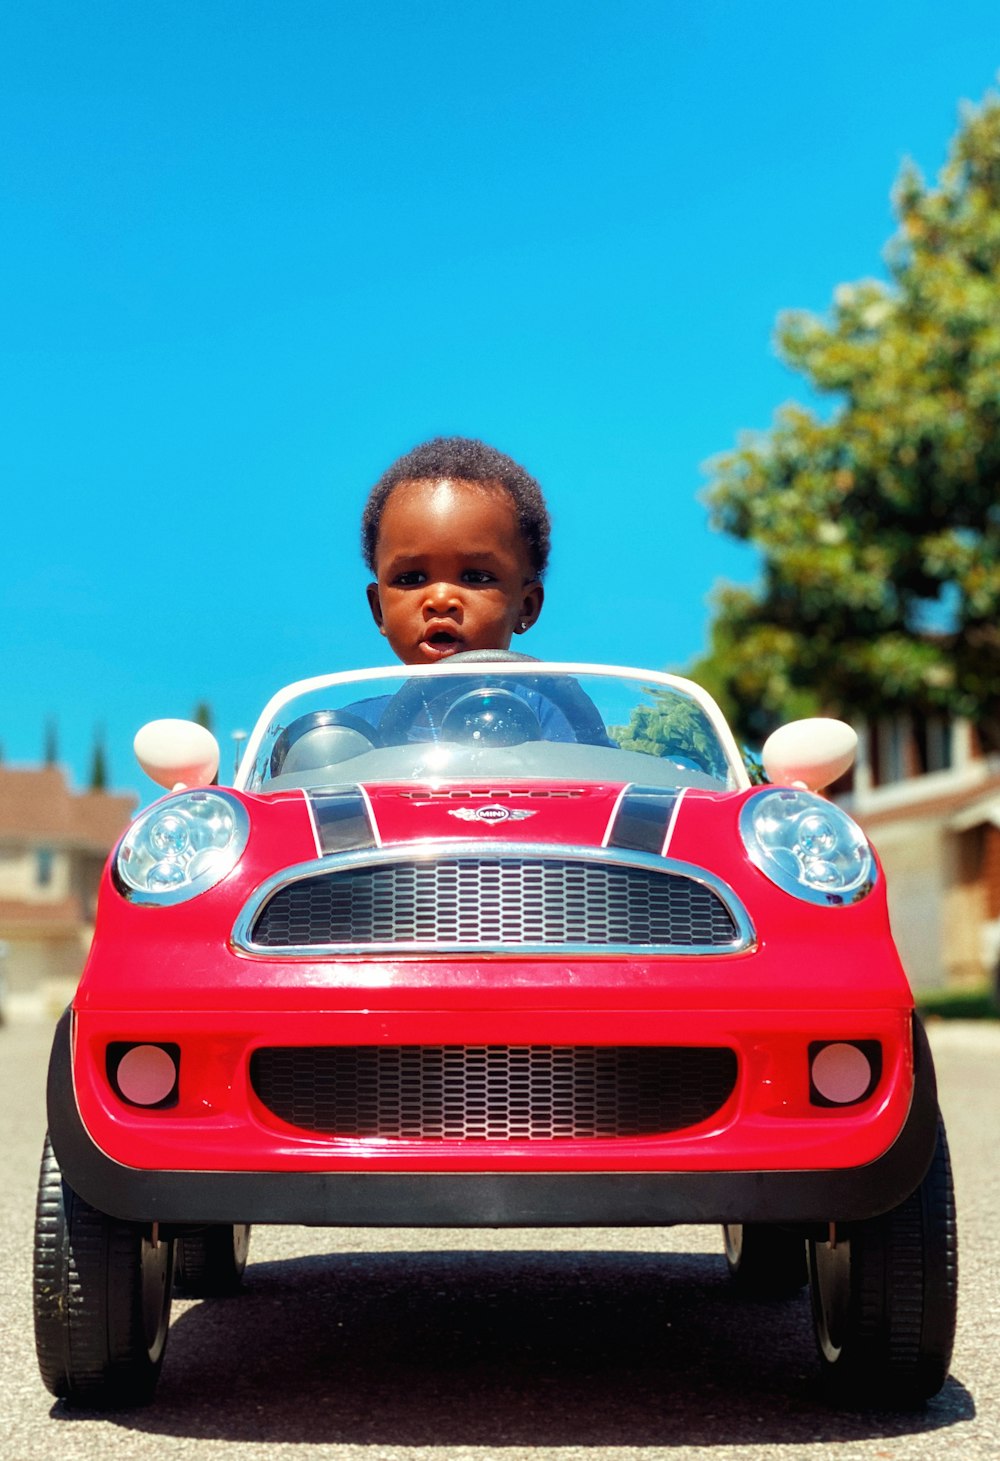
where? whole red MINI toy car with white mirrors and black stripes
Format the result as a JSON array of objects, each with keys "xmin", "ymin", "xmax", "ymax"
[{"xmin": 35, "ymin": 652, "xmax": 956, "ymax": 1405}]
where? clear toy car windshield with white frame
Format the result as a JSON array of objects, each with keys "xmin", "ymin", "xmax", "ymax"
[{"xmin": 237, "ymin": 662, "xmax": 747, "ymax": 792}]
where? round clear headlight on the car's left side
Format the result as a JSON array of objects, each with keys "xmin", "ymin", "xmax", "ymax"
[{"xmin": 114, "ymin": 790, "xmax": 250, "ymax": 903}]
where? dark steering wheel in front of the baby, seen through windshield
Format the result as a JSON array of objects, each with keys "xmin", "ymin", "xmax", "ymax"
[{"xmin": 379, "ymin": 649, "xmax": 608, "ymax": 745}]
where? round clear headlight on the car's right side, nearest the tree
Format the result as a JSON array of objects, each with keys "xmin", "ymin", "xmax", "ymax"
[{"xmin": 740, "ymin": 789, "xmax": 876, "ymax": 907}]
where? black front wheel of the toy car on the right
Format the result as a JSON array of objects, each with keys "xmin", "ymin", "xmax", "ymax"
[{"xmin": 807, "ymin": 1119, "xmax": 958, "ymax": 1405}]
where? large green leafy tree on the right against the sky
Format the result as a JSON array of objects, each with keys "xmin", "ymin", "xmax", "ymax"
[{"xmin": 698, "ymin": 96, "xmax": 1000, "ymax": 747}]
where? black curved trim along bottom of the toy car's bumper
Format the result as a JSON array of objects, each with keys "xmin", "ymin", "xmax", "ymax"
[{"xmin": 48, "ymin": 1012, "xmax": 937, "ymax": 1227}]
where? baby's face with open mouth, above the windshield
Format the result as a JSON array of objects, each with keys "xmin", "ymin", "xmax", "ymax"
[{"xmin": 368, "ymin": 478, "xmax": 542, "ymax": 665}]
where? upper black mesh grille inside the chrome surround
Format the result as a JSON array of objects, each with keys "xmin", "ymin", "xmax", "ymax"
[{"xmin": 251, "ymin": 858, "xmax": 737, "ymax": 948}]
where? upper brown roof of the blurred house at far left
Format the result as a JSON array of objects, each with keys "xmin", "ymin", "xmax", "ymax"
[{"xmin": 0, "ymin": 766, "xmax": 136, "ymax": 853}]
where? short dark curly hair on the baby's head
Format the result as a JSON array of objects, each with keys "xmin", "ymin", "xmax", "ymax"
[{"xmin": 361, "ymin": 437, "xmax": 551, "ymax": 579}]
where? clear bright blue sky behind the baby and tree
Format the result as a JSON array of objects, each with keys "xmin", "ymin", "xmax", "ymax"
[{"xmin": 0, "ymin": 0, "xmax": 1000, "ymax": 796}]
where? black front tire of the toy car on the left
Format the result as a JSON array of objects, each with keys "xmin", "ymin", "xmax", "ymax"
[{"xmin": 34, "ymin": 1138, "xmax": 174, "ymax": 1410}]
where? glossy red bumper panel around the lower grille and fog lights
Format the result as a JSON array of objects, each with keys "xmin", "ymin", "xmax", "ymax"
[{"xmin": 66, "ymin": 989, "xmax": 912, "ymax": 1172}]
